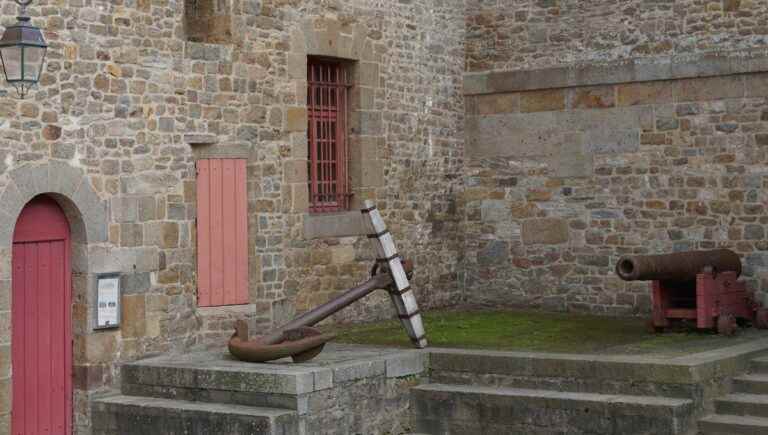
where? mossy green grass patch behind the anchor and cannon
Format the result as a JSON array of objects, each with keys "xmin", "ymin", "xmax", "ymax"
[{"xmin": 324, "ymin": 311, "xmax": 766, "ymax": 354}]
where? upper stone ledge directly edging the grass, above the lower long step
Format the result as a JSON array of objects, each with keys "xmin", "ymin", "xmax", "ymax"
[{"xmin": 430, "ymin": 349, "xmax": 751, "ymax": 406}]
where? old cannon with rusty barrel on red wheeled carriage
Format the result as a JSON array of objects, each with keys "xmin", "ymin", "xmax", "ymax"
[{"xmin": 616, "ymin": 249, "xmax": 768, "ymax": 335}]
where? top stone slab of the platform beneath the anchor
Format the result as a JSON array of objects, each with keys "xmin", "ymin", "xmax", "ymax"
[{"xmin": 121, "ymin": 344, "xmax": 427, "ymax": 415}]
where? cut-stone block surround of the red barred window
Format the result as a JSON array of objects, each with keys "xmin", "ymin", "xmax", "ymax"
[{"xmin": 283, "ymin": 17, "xmax": 385, "ymax": 239}]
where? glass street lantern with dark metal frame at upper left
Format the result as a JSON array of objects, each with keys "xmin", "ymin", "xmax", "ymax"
[{"xmin": 0, "ymin": 0, "xmax": 48, "ymax": 98}]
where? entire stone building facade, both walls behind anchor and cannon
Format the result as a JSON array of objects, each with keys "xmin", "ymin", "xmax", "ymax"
[{"xmin": 0, "ymin": 0, "xmax": 768, "ymax": 434}]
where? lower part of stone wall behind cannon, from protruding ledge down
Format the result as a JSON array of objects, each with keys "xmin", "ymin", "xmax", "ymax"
[{"xmin": 463, "ymin": 53, "xmax": 768, "ymax": 314}]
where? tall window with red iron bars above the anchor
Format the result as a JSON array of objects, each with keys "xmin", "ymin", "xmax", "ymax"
[{"xmin": 307, "ymin": 58, "xmax": 351, "ymax": 213}]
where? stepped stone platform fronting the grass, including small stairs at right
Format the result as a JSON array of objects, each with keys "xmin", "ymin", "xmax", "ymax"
[{"xmin": 411, "ymin": 338, "xmax": 768, "ymax": 435}]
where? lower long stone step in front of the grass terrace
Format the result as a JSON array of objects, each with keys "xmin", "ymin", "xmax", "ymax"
[{"xmin": 411, "ymin": 384, "xmax": 694, "ymax": 435}]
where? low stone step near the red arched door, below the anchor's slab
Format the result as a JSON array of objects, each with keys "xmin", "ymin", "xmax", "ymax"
[{"xmin": 91, "ymin": 395, "xmax": 299, "ymax": 435}]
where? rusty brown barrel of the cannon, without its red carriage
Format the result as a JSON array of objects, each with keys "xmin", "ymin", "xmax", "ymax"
[{"xmin": 616, "ymin": 249, "xmax": 741, "ymax": 281}]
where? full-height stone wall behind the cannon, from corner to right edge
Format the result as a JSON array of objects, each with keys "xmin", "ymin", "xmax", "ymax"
[{"xmin": 460, "ymin": 0, "xmax": 768, "ymax": 314}]
